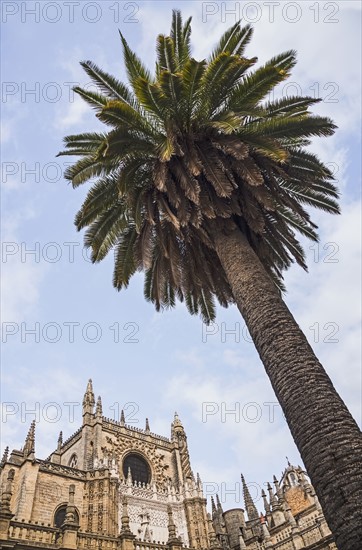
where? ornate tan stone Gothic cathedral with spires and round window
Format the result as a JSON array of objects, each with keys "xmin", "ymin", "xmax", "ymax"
[{"xmin": 0, "ymin": 380, "xmax": 337, "ymax": 550}]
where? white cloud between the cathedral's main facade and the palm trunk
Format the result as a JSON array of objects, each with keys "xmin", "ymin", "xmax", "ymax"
[{"xmin": 165, "ymin": 362, "xmax": 301, "ymax": 504}]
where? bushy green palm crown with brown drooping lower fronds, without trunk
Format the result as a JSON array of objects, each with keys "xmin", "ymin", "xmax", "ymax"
[{"xmin": 59, "ymin": 11, "xmax": 338, "ymax": 321}]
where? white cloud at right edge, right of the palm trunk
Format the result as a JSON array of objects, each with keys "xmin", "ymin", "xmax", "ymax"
[{"xmin": 286, "ymin": 201, "xmax": 362, "ymax": 421}]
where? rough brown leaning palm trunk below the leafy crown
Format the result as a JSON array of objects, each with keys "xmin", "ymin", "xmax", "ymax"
[{"xmin": 213, "ymin": 226, "xmax": 362, "ymax": 550}]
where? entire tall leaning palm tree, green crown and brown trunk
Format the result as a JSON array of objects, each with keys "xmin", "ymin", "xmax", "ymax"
[{"xmin": 60, "ymin": 11, "xmax": 362, "ymax": 550}]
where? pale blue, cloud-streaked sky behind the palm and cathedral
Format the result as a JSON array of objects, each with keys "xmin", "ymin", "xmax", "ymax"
[{"xmin": 0, "ymin": 0, "xmax": 362, "ymax": 509}]
